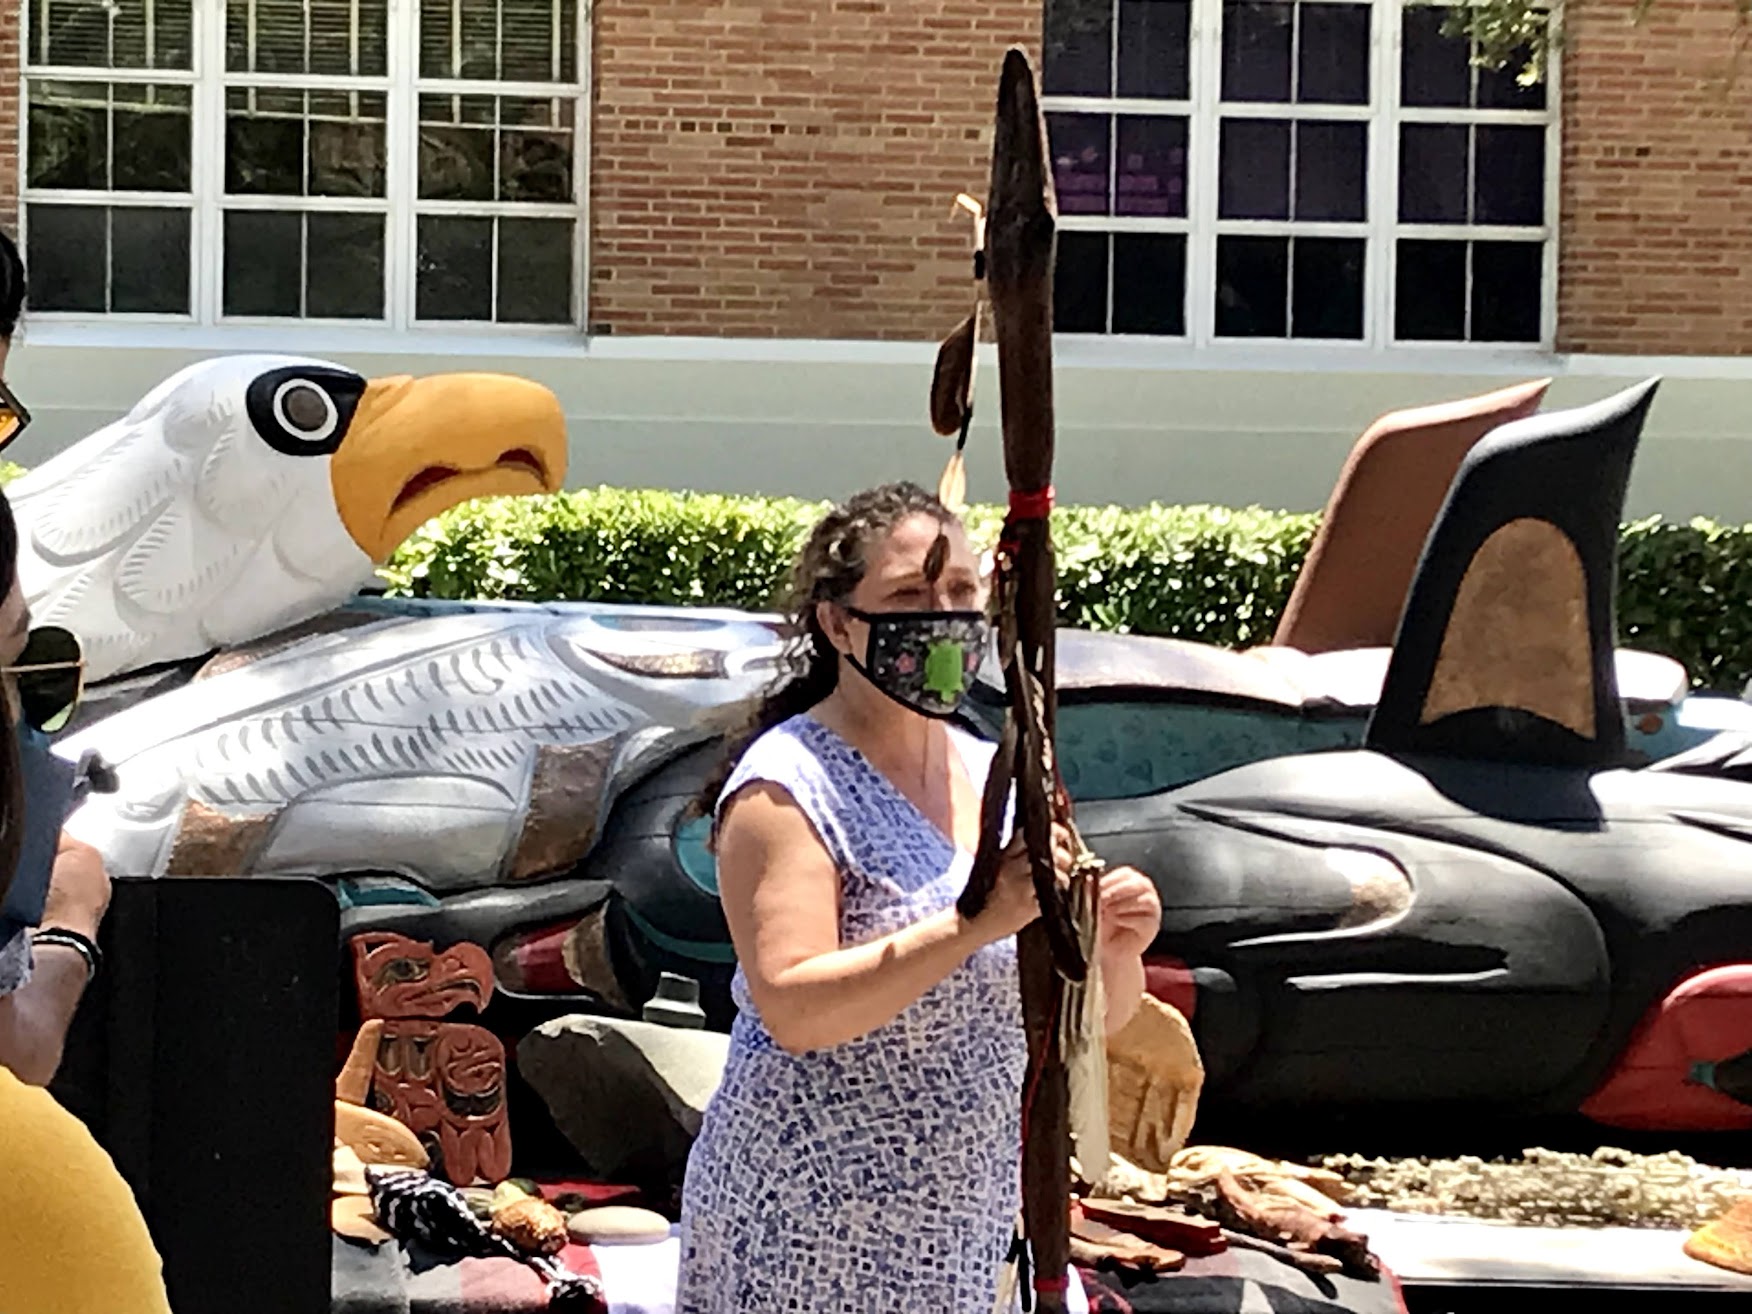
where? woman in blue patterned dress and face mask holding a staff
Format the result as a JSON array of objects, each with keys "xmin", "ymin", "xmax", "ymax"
[{"xmin": 676, "ymin": 484, "xmax": 1162, "ymax": 1314}]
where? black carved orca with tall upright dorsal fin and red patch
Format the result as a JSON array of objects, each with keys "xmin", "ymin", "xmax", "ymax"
[{"xmin": 1079, "ymin": 382, "xmax": 1752, "ymax": 1130}]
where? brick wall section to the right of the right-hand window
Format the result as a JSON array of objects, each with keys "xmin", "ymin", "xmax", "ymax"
[{"xmin": 1558, "ymin": 0, "xmax": 1752, "ymax": 356}]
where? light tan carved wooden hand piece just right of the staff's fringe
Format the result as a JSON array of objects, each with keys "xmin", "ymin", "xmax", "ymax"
[{"xmin": 1107, "ymin": 995, "xmax": 1204, "ymax": 1172}]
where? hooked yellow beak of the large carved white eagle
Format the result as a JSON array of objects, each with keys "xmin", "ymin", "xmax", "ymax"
[{"xmin": 329, "ymin": 373, "xmax": 566, "ymax": 564}]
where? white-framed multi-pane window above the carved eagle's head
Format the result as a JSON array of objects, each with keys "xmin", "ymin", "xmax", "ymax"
[{"xmin": 21, "ymin": 0, "xmax": 587, "ymax": 328}]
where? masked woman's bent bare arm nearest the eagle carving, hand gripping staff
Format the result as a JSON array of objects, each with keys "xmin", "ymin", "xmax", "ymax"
[{"xmin": 718, "ymin": 783, "xmax": 1039, "ymax": 1053}]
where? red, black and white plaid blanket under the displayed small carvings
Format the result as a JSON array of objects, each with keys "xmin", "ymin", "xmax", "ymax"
[{"xmin": 333, "ymin": 1237, "xmax": 1405, "ymax": 1314}]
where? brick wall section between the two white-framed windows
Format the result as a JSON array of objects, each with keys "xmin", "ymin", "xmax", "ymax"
[{"xmin": 590, "ymin": 0, "xmax": 1042, "ymax": 340}]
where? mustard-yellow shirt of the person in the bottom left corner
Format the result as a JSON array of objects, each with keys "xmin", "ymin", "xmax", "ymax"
[{"xmin": 0, "ymin": 1069, "xmax": 170, "ymax": 1314}]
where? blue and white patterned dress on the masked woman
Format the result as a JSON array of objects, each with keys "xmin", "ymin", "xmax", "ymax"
[{"xmin": 676, "ymin": 717, "xmax": 1027, "ymax": 1314}]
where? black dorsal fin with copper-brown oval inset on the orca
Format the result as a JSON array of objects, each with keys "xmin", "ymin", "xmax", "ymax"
[{"xmin": 1367, "ymin": 378, "xmax": 1659, "ymax": 767}]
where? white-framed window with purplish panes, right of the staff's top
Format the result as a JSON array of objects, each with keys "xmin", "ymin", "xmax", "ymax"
[{"xmin": 1041, "ymin": 0, "xmax": 1559, "ymax": 347}]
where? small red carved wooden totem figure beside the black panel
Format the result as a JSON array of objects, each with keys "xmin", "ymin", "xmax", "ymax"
[{"xmin": 352, "ymin": 932, "xmax": 512, "ymax": 1186}]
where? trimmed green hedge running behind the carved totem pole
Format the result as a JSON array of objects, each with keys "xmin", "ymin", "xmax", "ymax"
[{"xmin": 385, "ymin": 489, "xmax": 1752, "ymax": 692}]
